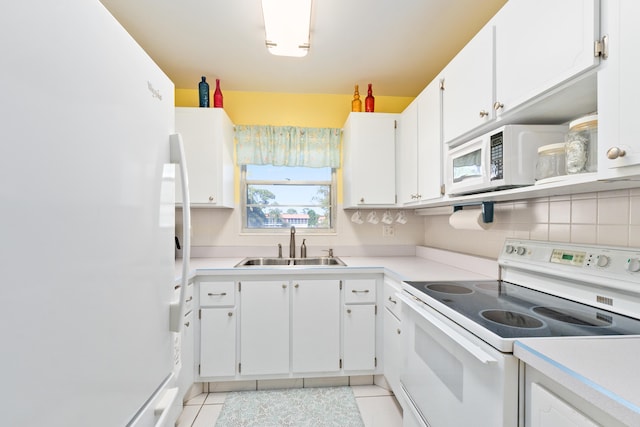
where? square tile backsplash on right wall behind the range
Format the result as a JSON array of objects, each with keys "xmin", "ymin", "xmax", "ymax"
[{"xmin": 425, "ymin": 188, "xmax": 640, "ymax": 258}]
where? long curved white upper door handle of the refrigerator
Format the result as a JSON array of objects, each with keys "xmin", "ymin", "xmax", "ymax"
[{"xmin": 169, "ymin": 133, "xmax": 191, "ymax": 332}]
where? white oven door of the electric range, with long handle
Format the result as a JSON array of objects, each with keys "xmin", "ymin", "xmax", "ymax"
[{"xmin": 396, "ymin": 292, "xmax": 518, "ymax": 427}]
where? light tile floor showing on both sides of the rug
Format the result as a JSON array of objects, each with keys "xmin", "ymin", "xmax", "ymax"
[{"xmin": 177, "ymin": 385, "xmax": 402, "ymax": 427}]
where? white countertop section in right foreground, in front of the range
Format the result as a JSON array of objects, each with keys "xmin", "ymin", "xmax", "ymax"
[{"xmin": 513, "ymin": 336, "xmax": 640, "ymax": 426}]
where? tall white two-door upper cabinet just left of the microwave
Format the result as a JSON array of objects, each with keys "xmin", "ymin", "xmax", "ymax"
[{"xmin": 396, "ymin": 79, "xmax": 442, "ymax": 206}]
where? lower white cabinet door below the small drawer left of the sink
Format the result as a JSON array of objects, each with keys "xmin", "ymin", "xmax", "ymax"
[{"xmin": 200, "ymin": 307, "xmax": 236, "ymax": 377}]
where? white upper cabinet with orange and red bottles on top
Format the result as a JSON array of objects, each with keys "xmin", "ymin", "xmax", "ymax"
[{"xmin": 342, "ymin": 113, "xmax": 400, "ymax": 208}]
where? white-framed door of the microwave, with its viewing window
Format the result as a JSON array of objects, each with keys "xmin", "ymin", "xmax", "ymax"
[{"xmin": 446, "ymin": 136, "xmax": 491, "ymax": 194}]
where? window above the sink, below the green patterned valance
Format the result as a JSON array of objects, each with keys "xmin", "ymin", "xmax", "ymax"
[{"xmin": 241, "ymin": 165, "xmax": 336, "ymax": 233}]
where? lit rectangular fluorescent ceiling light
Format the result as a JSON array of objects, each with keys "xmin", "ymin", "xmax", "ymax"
[{"xmin": 262, "ymin": 0, "xmax": 312, "ymax": 57}]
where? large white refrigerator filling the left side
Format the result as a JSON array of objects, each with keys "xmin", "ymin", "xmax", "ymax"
[{"xmin": 0, "ymin": 0, "xmax": 188, "ymax": 427}]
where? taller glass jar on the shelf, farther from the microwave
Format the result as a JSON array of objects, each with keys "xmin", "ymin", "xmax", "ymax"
[{"xmin": 566, "ymin": 114, "xmax": 598, "ymax": 174}]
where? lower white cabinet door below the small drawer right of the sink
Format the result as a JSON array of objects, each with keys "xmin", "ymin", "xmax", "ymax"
[{"xmin": 343, "ymin": 304, "xmax": 376, "ymax": 371}]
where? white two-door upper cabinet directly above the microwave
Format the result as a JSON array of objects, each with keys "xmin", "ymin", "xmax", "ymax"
[{"xmin": 442, "ymin": 0, "xmax": 600, "ymax": 145}]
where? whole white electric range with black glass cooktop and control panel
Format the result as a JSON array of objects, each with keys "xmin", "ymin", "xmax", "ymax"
[{"xmin": 397, "ymin": 239, "xmax": 640, "ymax": 427}]
